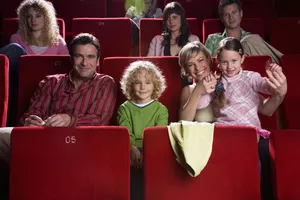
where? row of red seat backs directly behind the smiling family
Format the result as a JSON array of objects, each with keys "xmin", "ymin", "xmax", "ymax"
[{"xmin": 0, "ymin": 54, "xmax": 300, "ymax": 130}]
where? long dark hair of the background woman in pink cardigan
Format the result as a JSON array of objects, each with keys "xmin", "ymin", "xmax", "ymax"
[{"xmin": 162, "ymin": 1, "xmax": 191, "ymax": 47}]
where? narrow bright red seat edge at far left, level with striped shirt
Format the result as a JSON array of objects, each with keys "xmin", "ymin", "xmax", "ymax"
[{"xmin": 0, "ymin": 54, "xmax": 9, "ymax": 127}]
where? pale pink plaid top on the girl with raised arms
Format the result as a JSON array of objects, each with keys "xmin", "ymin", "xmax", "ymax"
[{"xmin": 213, "ymin": 70, "xmax": 271, "ymax": 128}]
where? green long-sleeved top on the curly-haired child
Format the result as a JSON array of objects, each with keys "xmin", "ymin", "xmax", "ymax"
[{"xmin": 118, "ymin": 101, "xmax": 169, "ymax": 148}]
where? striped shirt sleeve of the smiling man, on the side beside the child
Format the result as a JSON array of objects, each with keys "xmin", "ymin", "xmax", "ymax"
[{"xmin": 66, "ymin": 78, "xmax": 117, "ymax": 126}]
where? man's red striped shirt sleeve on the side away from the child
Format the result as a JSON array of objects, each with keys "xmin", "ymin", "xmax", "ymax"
[{"xmin": 20, "ymin": 77, "xmax": 55, "ymax": 126}]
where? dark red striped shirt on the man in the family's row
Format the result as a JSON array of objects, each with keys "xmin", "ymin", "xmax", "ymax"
[{"xmin": 20, "ymin": 72, "xmax": 117, "ymax": 126}]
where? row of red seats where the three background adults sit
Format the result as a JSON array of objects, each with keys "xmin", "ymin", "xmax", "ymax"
[{"xmin": 1, "ymin": 18, "xmax": 300, "ymax": 59}]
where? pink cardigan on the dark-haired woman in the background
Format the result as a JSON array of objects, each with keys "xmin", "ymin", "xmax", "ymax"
[{"xmin": 147, "ymin": 35, "xmax": 200, "ymax": 56}]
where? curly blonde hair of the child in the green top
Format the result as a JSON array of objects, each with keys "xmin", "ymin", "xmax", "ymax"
[{"xmin": 120, "ymin": 61, "xmax": 166, "ymax": 100}]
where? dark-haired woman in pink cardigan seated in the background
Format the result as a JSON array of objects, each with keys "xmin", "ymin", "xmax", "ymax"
[{"xmin": 147, "ymin": 2, "xmax": 199, "ymax": 56}]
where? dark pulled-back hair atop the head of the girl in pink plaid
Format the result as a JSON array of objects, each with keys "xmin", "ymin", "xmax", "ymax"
[{"xmin": 216, "ymin": 37, "xmax": 244, "ymax": 60}]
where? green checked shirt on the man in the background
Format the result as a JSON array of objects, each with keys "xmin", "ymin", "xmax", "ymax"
[{"xmin": 205, "ymin": 28, "xmax": 250, "ymax": 56}]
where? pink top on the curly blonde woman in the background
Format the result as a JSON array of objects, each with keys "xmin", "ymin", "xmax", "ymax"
[{"xmin": 10, "ymin": 32, "xmax": 69, "ymax": 55}]
